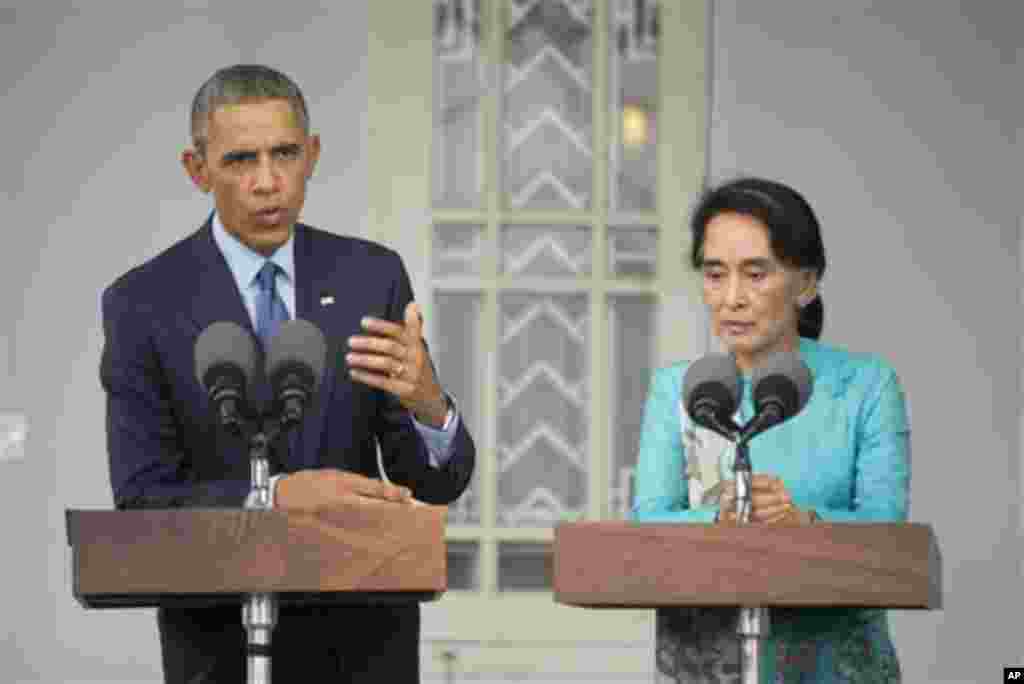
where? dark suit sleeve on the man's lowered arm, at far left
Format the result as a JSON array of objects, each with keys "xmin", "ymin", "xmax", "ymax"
[{"xmin": 99, "ymin": 283, "xmax": 249, "ymax": 508}]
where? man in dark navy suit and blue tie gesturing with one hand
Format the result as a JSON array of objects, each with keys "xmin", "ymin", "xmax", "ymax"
[{"xmin": 100, "ymin": 66, "xmax": 475, "ymax": 683}]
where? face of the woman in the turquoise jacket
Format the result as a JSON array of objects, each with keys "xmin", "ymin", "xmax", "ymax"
[{"xmin": 701, "ymin": 212, "xmax": 816, "ymax": 373}]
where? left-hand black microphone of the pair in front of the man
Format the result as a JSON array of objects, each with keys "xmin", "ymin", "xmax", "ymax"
[{"xmin": 195, "ymin": 320, "xmax": 257, "ymax": 434}]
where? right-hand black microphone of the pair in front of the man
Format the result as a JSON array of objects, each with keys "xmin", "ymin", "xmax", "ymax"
[{"xmin": 266, "ymin": 318, "xmax": 327, "ymax": 429}]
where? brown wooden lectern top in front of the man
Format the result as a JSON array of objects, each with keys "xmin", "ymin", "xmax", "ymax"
[{"xmin": 67, "ymin": 501, "xmax": 447, "ymax": 608}]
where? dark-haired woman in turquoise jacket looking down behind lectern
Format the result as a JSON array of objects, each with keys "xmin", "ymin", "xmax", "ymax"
[{"xmin": 633, "ymin": 178, "xmax": 910, "ymax": 684}]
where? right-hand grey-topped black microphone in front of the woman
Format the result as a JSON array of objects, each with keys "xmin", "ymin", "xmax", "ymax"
[{"xmin": 742, "ymin": 351, "xmax": 813, "ymax": 440}]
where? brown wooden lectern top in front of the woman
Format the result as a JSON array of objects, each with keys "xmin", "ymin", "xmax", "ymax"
[{"xmin": 554, "ymin": 521, "xmax": 942, "ymax": 609}]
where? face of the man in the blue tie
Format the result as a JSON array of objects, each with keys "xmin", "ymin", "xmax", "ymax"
[{"xmin": 182, "ymin": 98, "xmax": 319, "ymax": 256}]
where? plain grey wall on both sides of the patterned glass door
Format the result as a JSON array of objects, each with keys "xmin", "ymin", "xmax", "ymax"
[{"xmin": 0, "ymin": 0, "xmax": 1024, "ymax": 682}]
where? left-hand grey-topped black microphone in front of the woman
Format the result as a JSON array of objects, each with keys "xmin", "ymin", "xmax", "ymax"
[{"xmin": 683, "ymin": 354, "xmax": 739, "ymax": 439}]
